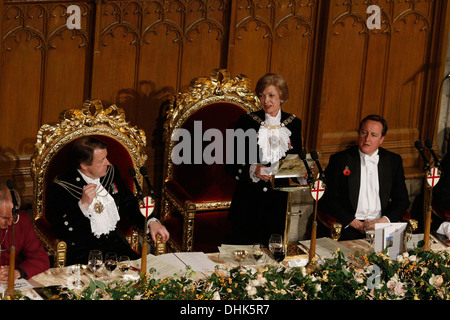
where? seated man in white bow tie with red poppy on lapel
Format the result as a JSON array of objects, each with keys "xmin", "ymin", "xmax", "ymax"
[{"xmin": 318, "ymin": 115, "xmax": 409, "ymax": 240}]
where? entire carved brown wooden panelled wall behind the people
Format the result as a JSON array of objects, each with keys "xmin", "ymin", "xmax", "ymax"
[{"xmin": 0, "ymin": 0, "xmax": 450, "ymax": 206}]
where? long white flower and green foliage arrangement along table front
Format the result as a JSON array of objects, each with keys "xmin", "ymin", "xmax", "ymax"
[{"xmin": 38, "ymin": 249, "xmax": 450, "ymax": 300}]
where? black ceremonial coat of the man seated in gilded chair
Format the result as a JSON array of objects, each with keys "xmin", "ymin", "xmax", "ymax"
[{"xmin": 45, "ymin": 167, "xmax": 145, "ymax": 264}]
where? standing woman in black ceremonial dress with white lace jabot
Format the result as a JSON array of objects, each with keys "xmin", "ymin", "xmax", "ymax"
[{"xmin": 227, "ymin": 74, "xmax": 302, "ymax": 245}]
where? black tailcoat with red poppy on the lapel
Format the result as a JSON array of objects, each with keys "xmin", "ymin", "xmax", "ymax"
[{"xmin": 319, "ymin": 146, "xmax": 409, "ymax": 227}]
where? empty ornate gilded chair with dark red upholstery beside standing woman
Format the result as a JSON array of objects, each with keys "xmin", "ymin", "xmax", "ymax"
[{"xmin": 161, "ymin": 69, "xmax": 260, "ymax": 252}]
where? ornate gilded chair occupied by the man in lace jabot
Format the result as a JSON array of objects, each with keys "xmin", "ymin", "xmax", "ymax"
[{"xmin": 31, "ymin": 100, "xmax": 165, "ymax": 267}]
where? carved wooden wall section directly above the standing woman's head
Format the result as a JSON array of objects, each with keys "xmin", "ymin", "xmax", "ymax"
[{"xmin": 229, "ymin": 0, "xmax": 318, "ymax": 122}]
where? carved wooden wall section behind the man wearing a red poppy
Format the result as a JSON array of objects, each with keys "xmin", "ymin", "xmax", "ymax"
[{"xmin": 316, "ymin": 0, "xmax": 442, "ymax": 178}]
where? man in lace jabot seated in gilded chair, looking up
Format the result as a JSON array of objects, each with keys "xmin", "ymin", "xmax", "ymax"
[{"xmin": 46, "ymin": 137, "xmax": 169, "ymax": 264}]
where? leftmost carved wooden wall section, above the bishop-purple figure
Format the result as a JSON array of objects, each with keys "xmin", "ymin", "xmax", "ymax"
[{"xmin": 0, "ymin": 1, "xmax": 92, "ymax": 204}]
